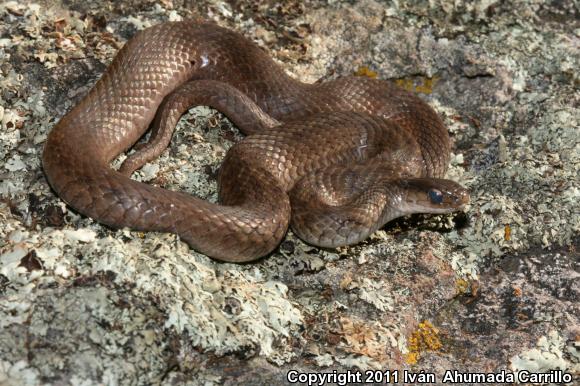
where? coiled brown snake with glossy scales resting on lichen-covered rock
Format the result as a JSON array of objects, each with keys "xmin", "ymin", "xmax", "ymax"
[{"xmin": 43, "ymin": 21, "xmax": 469, "ymax": 262}]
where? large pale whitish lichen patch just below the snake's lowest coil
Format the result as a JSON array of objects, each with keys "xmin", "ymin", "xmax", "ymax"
[{"xmin": 60, "ymin": 229, "xmax": 301, "ymax": 356}]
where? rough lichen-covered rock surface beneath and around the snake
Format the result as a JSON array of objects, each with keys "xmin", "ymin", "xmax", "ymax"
[{"xmin": 0, "ymin": 0, "xmax": 580, "ymax": 385}]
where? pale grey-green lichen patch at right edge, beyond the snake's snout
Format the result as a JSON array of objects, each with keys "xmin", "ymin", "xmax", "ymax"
[{"xmin": 450, "ymin": 99, "xmax": 580, "ymax": 257}]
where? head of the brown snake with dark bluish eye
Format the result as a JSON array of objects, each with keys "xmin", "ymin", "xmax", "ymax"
[{"xmin": 400, "ymin": 178, "xmax": 469, "ymax": 214}]
